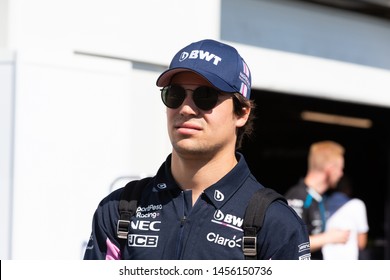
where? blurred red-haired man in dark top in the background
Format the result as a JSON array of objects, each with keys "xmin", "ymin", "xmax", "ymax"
[{"xmin": 285, "ymin": 141, "xmax": 349, "ymax": 259}]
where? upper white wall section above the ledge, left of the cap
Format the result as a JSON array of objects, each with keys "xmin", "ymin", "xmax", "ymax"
[{"xmin": 8, "ymin": 0, "xmax": 220, "ymax": 64}]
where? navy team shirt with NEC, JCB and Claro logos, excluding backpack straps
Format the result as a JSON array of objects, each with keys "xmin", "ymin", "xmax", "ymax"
[{"xmin": 84, "ymin": 153, "xmax": 310, "ymax": 260}]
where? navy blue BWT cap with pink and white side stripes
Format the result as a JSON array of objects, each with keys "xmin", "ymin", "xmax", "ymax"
[{"xmin": 156, "ymin": 40, "xmax": 251, "ymax": 99}]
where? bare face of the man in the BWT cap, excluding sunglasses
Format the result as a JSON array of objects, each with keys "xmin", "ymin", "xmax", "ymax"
[{"xmin": 167, "ymin": 72, "xmax": 249, "ymax": 157}]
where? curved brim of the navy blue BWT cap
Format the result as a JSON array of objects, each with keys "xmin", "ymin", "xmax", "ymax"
[{"xmin": 156, "ymin": 67, "xmax": 238, "ymax": 92}]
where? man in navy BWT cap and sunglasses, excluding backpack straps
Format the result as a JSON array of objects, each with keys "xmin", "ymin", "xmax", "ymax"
[{"xmin": 84, "ymin": 40, "xmax": 310, "ymax": 259}]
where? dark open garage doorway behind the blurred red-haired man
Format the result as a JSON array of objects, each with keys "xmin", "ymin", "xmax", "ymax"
[{"xmin": 242, "ymin": 90, "xmax": 390, "ymax": 259}]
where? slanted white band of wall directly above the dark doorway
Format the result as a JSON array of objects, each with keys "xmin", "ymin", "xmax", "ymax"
[{"xmin": 236, "ymin": 42, "xmax": 390, "ymax": 107}]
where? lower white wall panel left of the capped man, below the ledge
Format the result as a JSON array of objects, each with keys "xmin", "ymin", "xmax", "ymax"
[{"xmin": 6, "ymin": 49, "xmax": 170, "ymax": 259}]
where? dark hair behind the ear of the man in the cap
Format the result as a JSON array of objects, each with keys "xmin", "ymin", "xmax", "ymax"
[{"xmin": 233, "ymin": 92, "xmax": 256, "ymax": 150}]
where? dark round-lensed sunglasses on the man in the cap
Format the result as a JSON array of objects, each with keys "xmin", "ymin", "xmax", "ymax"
[{"xmin": 161, "ymin": 85, "xmax": 221, "ymax": 111}]
